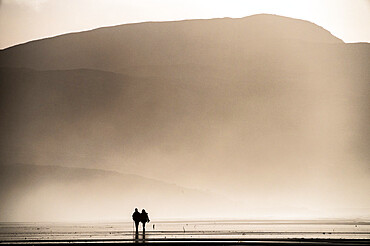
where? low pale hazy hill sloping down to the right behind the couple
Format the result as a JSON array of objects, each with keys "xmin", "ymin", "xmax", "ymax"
[{"xmin": 0, "ymin": 164, "xmax": 238, "ymax": 222}]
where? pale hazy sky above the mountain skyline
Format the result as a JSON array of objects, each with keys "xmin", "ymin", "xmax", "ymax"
[{"xmin": 0, "ymin": 0, "xmax": 370, "ymax": 49}]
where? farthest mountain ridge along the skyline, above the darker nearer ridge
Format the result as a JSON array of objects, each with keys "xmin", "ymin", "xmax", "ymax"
[{"xmin": 0, "ymin": 15, "xmax": 343, "ymax": 72}]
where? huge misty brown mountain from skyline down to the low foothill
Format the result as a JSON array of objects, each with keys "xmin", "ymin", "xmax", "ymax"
[{"xmin": 0, "ymin": 15, "xmax": 370, "ymax": 218}]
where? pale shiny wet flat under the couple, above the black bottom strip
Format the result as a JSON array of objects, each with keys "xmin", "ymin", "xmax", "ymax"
[{"xmin": 0, "ymin": 221, "xmax": 370, "ymax": 243}]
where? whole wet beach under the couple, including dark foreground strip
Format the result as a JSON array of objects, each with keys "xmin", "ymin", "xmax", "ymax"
[{"xmin": 0, "ymin": 221, "xmax": 370, "ymax": 245}]
